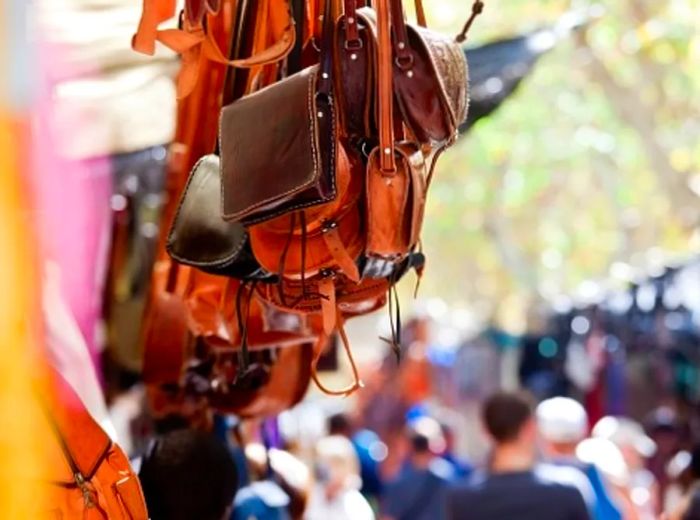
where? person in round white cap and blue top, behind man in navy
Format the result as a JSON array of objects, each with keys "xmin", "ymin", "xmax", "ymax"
[{"xmin": 536, "ymin": 397, "xmax": 622, "ymax": 520}]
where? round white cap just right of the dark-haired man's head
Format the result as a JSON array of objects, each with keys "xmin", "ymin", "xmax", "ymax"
[{"xmin": 535, "ymin": 397, "xmax": 588, "ymax": 442}]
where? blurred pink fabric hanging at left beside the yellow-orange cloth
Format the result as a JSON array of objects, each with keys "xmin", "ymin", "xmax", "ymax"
[{"xmin": 31, "ymin": 42, "xmax": 112, "ymax": 366}]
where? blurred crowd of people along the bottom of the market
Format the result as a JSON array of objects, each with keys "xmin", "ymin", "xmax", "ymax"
[{"xmin": 129, "ymin": 391, "xmax": 700, "ymax": 520}]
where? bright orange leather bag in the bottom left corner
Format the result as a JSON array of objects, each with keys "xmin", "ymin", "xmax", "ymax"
[{"xmin": 40, "ymin": 372, "xmax": 148, "ymax": 520}]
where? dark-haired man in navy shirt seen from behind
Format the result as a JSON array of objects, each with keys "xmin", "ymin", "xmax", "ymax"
[{"xmin": 446, "ymin": 392, "xmax": 590, "ymax": 520}]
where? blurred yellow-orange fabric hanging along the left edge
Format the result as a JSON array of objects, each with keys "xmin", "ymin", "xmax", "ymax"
[{"xmin": 0, "ymin": 114, "xmax": 51, "ymax": 519}]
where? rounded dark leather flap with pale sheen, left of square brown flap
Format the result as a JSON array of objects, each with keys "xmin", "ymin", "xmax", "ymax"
[{"xmin": 166, "ymin": 154, "xmax": 248, "ymax": 268}]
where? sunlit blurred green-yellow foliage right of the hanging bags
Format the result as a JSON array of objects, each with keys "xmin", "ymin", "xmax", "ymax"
[{"xmin": 422, "ymin": 0, "xmax": 700, "ymax": 320}]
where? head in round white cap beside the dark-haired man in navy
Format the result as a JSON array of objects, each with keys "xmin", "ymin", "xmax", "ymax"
[{"xmin": 536, "ymin": 397, "xmax": 588, "ymax": 457}]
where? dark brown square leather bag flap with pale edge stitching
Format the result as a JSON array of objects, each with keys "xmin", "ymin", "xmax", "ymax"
[{"xmin": 219, "ymin": 67, "xmax": 335, "ymax": 224}]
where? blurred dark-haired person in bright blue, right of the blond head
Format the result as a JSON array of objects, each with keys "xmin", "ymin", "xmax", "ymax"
[{"xmin": 328, "ymin": 413, "xmax": 386, "ymax": 501}]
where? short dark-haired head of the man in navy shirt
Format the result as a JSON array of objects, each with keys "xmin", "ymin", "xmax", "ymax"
[{"xmin": 481, "ymin": 392, "xmax": 536, "ymax": 453}]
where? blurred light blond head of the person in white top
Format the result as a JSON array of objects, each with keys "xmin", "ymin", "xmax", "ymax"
[{"xmin": 316, "ymin": 435, "xmax": 362, "ymax": 491}]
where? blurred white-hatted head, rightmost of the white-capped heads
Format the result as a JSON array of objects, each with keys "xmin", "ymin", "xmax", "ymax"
[{"xmin": 591, "ymin": 415, "xmax": 657, "ymax": 471}]
